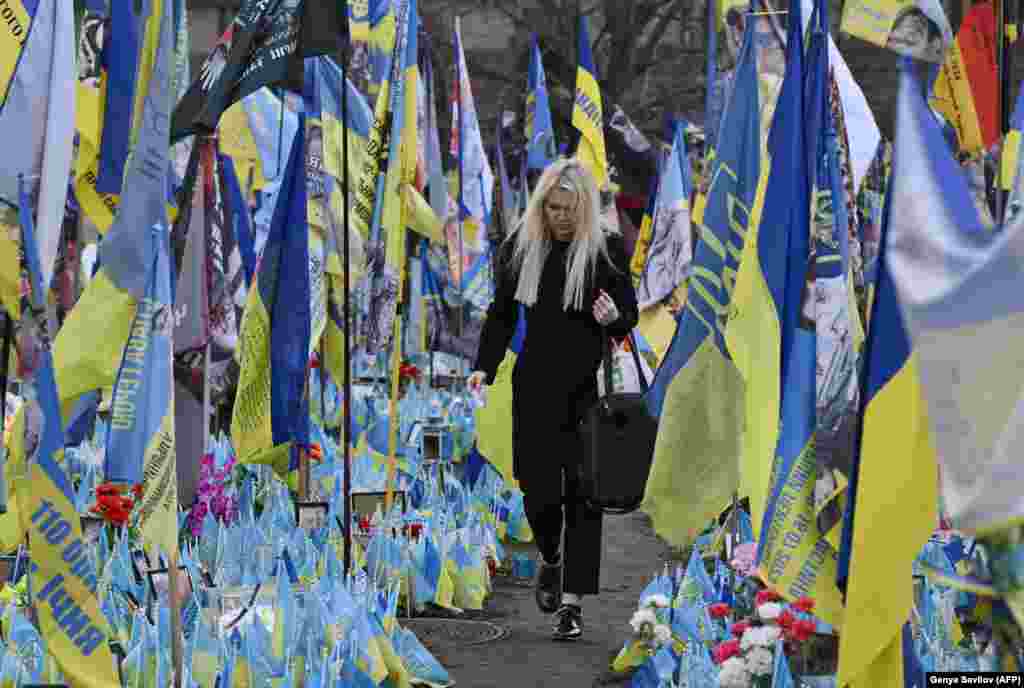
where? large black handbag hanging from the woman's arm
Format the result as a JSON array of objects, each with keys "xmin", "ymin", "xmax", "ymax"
[{"xmin": 580, "ymin": 333, "xmax": 657, "ymax": 514}]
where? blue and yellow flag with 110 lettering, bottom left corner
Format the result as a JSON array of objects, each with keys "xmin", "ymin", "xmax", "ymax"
[{"xmin": 18, "ymin": 179, "xmax": 120, "ymax": 688}]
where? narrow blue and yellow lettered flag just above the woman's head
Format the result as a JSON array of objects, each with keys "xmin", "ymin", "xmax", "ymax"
[{"xmin": 572, "ymin": 15, "xmax": 609, "ymax": 189}]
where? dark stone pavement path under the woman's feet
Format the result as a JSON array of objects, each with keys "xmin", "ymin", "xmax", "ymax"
[{"xmin": 415, "ymin": 512, "xmax": 675, "ymax": 688}]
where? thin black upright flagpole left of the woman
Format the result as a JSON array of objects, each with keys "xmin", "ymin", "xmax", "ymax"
[{"xmin": 341, "ymin": 34, "xmax": 352, "ymax": 577}]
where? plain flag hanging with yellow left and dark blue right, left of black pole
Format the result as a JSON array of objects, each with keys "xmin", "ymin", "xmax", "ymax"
[{"xmin": 231, "ymin": 117, "xmax": 311, "ymax": 479}]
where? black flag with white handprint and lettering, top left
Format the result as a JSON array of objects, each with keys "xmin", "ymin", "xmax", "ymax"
[{"xmin": 171, "ymin": 0, "xmax": 348, "ymax": 143}]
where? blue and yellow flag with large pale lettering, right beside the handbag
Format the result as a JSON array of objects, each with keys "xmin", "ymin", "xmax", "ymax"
[{"xmin": 643, "ymin": 18, "xmax": 761, "ymax": 546}]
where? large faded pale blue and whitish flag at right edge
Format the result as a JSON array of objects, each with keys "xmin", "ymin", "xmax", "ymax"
[{"xmin": 887, "ymin": 57, "xmax": 1024, "ymax": 534}]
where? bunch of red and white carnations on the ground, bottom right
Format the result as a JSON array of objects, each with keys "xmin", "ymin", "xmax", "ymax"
[{"xmin": 709, "ymin": 590, "xmax": 817, "ymax": 688}]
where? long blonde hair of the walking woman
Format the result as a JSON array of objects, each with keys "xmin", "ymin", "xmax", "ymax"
[{"xmin": 506, "ymin": 158, "xmax": 611, "ymax": 310}]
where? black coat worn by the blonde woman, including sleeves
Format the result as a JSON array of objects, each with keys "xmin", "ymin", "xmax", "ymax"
[{"xmin": 474, "ymin": 237, "xmax": 639, "ymax": 480}]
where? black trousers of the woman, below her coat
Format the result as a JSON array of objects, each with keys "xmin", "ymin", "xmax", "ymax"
[{"xmin": 516, "ymin": 426, "xmax": 602, "ymax": 595}]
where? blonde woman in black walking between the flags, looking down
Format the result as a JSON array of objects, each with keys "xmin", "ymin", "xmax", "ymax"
[{"xmin": 468, "ymin": 159, "xmax": 638, "ymax": 640}]
